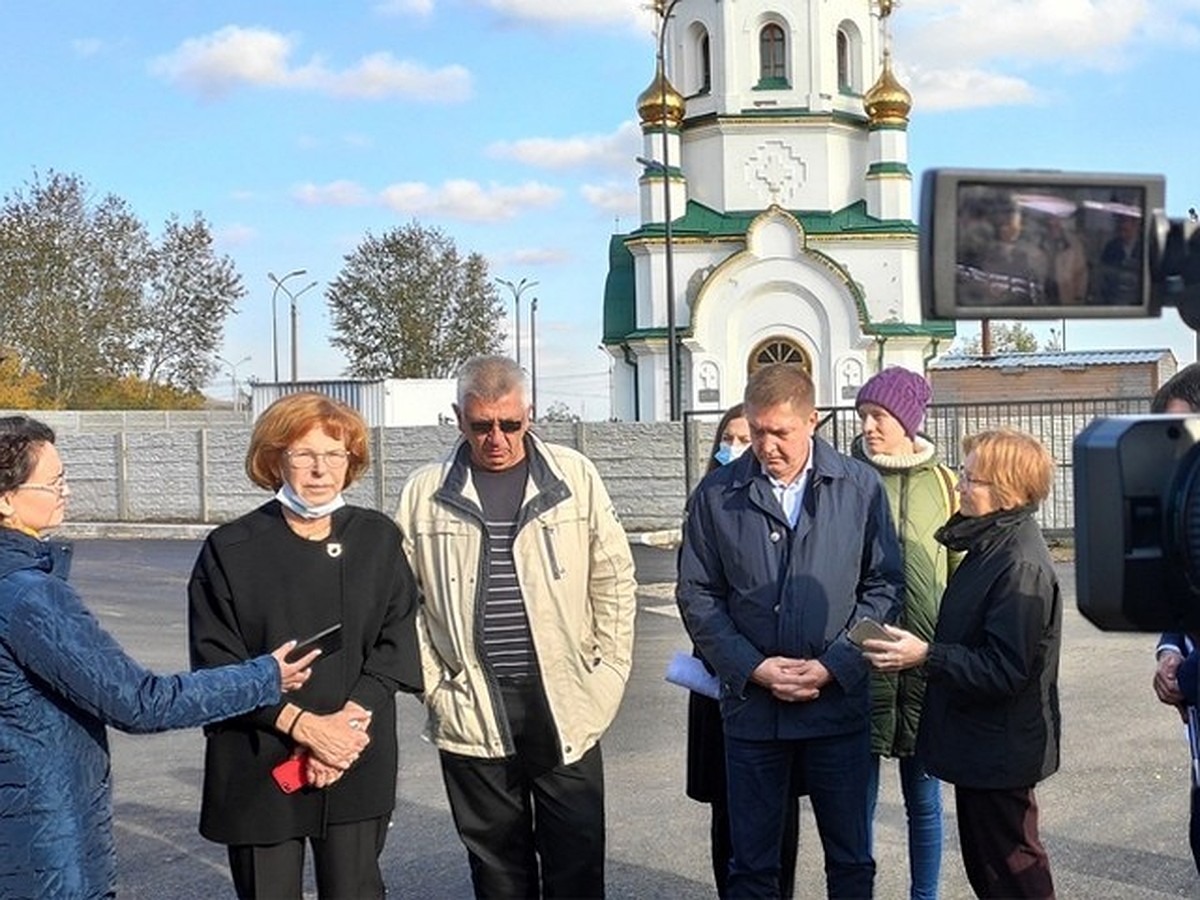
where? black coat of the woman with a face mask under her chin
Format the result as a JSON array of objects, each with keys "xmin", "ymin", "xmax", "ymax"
[{"xmin": 188, "ymin": 500, "xmax": 421, "ymax": 845}]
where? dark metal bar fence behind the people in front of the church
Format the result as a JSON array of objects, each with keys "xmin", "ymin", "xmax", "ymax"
[{"xmin": 684, "ymin": 397, "xmax": 1150, "ymax": 534}]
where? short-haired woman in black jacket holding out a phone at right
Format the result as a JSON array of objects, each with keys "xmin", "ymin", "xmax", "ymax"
[{"xmin": 864, "ymin": 428, "xmax": 1062, "ymax": 899}]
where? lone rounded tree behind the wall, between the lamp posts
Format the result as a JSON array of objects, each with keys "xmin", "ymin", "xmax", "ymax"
[{"xmin": 326, "ymin": 222, "xmax": 503, "ymax": 378}]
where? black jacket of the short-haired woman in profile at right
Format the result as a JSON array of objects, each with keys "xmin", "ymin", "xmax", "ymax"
[{"xmin": 917, "ymin": 508, "xmax": 1062, "ymax": 790}]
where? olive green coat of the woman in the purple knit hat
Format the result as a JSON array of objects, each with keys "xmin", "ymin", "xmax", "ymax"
[{"xmin": 852, "ymin": 437, "xmax": 958, "ymax": 756}]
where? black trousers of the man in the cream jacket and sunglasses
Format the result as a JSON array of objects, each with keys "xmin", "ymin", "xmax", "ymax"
[{"xmin": 440, "ymin": 678, "xmax": 605, "ymax": 900}]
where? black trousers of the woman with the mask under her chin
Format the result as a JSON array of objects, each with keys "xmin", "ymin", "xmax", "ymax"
[{"xmin": 228, "ymin": 816, "xmax": 389, "ymax": 900}]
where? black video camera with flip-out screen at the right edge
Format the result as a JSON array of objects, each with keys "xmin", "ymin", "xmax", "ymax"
[{"xmin": 920, "ymin": 169, "xmax": 1200, "ymax": 631}]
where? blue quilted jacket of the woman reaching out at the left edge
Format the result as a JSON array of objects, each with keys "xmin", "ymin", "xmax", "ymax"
[{"xmin": 0, "ymin": 527, "xmax": 280, "ymax": 900}]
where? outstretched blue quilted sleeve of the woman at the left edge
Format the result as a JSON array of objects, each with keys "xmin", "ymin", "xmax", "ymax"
[{"xmin": 7, "ymin": 580, "xmax": 280, "ymax": 733}]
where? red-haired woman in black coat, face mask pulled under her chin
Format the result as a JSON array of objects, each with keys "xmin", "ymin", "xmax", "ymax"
[{"xmin": 188, "ymin": 394, "xmax": 421, "ymax": 900}]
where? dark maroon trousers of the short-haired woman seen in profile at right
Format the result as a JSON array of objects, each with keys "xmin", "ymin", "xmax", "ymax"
[{"xmin": 954, "ymin": 787, "xmax": 1055, "ymax": 900}]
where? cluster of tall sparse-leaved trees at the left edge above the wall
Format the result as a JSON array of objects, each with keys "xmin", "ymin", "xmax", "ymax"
[{"xmin": 0, "ymin": 172, "xmax": 245, "ymax": 408}]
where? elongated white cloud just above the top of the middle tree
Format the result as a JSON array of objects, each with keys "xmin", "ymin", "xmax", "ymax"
[{"xmin": 380, "ymin": 179, "xmax": 563, "ymax": 222}]
